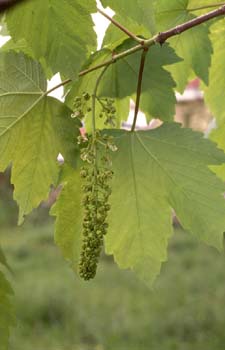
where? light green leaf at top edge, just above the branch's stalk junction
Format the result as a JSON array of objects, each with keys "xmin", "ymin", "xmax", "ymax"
[{"xmin": 102, "ymin": 0, "xmax": 155, "ymax": 34}]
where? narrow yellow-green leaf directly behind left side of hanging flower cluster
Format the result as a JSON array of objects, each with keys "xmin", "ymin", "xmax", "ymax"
[{"xmin": 51, "ymin": 165, "xmax": 83, "ymax": 272}]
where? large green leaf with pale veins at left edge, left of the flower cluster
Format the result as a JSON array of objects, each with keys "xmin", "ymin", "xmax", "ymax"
[{"xmin": 0, "ymin": 52, "xmax": 79, "ymax": 223}]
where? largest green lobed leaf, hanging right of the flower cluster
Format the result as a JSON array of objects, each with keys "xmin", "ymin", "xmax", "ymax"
[{"xmin": 106, "ymin": 123, "xmax": 225, "ymax": 284}]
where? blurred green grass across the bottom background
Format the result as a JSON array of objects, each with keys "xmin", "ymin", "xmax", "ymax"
[{"xmin": 1, "ymin": 224, "xmax": 225, "ymax": 350}]
